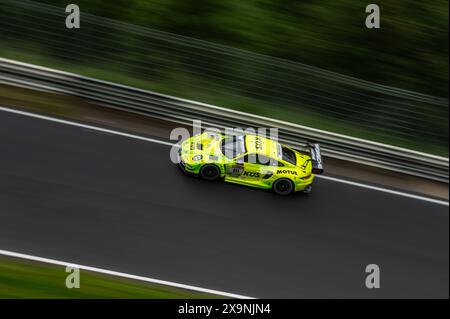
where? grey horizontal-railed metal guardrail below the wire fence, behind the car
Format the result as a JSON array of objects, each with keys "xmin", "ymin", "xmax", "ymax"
[{"xmin": 0, "ymin": 58, "xmax": 449, "ymax": 183}]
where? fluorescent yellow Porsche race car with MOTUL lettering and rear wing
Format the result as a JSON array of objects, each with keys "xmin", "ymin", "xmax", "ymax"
[{"xmin": 178, "ymin": 132, "xmax": 323, "ymax": 195}]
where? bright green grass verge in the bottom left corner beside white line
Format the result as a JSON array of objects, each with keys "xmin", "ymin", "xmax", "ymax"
[{"xmin": 0, "ymin": 256, "xmax": 217, "ymax": 299}]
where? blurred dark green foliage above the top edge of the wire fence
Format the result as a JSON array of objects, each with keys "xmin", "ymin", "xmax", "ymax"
[{"xmin": 37, "ymin": 0, "xmax": 448, "ymax": 97}]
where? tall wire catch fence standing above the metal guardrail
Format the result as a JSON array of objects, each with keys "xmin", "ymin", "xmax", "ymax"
[{"xmin": 0, "ymin": 0, "xmax": 449, "ymax": 157}]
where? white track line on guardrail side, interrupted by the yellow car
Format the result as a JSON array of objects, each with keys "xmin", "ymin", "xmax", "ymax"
[{"xmin": 0, "ymin": 106, "xmax": 449, "ymax": 206}]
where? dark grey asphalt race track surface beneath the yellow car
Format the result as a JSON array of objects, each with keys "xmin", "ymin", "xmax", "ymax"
[{"xmin": 0, "ymin": 112, "xmax": 449, "ymax": 298}]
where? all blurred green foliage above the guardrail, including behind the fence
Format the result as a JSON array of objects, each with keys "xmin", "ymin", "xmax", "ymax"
[{"xmin": 0, "ymin": 0, "xmax": 448, "ymax": 156}]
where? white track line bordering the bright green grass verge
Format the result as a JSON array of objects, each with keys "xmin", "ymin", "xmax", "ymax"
[{"xmin": 0, "ymin": 249, "xmax": 255, "ymax": 299}]
